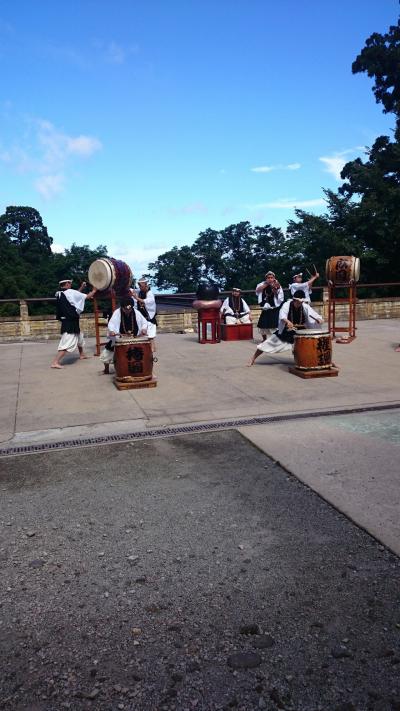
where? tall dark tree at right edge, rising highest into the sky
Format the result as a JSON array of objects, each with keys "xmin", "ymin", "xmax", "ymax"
[{"xmin": 339, "ymin": 23, "xmax": 400, "ymax": 281}]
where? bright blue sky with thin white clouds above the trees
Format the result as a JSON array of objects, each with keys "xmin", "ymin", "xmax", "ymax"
[{"xmin": 0, "ymin": 0, "xmax": 400, "ymax": 276}]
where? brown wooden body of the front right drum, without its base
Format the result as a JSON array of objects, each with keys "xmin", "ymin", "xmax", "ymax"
[{"xmin": 293, "ymin": 329, "xmax": 332, "ymax": 370}]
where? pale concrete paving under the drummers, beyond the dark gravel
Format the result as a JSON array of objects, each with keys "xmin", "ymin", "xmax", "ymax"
[{"xmin": 0, "ymin": 320, "xmax": 400, "ymax": 555}]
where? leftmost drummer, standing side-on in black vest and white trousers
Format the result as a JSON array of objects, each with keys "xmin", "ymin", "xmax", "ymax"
[{"xmin": 50, "ymin": 279, "xmax": 96, "ymax": 370}]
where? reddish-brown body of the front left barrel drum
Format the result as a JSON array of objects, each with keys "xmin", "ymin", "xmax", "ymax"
[{"xmin": 114, "ymin": 337, "xmax": 153, "ymax": 382}]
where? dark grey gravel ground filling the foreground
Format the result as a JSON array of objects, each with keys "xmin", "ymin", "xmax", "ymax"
[{"xmin": 0, "ymin": 431, "xmax": 400, "ymax": 711}]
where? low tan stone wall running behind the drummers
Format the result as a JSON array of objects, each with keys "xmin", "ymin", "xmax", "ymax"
[{"xmin": 0, "ymin": 297, "xmax": 400, "ymax": 343}]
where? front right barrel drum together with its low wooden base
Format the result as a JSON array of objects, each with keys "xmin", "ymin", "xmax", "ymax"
[{"xmin": 289, "ymin": 328, "xmax": 338, "ymax": 378}]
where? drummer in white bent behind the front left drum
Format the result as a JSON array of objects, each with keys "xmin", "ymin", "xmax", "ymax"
[{"xmin": 100, "ymin": 297, "xmax": 156, "ymax": 375}]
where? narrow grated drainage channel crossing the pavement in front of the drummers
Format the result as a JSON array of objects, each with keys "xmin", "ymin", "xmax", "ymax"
[{"xmin": 0, "ymin": 402, "xmax": 400, "ymax": 457}]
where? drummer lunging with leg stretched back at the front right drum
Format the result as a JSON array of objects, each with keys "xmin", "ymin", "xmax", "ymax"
[{"xmin": 248, "ymin": 289, "xmax": 323, "ymax": 366}]
